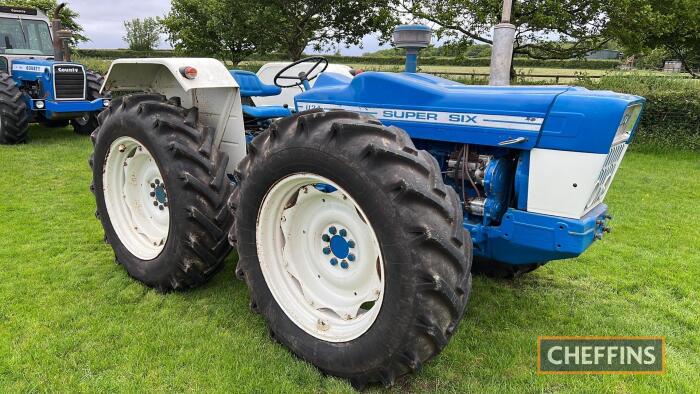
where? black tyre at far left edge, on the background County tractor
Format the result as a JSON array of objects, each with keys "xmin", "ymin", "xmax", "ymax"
[{"xmin": 0, "ymin": 72, "xmax": 29, "ymax": 145}]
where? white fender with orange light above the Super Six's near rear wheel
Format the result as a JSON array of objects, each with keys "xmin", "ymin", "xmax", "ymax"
[{"xmin": 102, "ymin": 58, "xmax": 246, "ymax": 174}]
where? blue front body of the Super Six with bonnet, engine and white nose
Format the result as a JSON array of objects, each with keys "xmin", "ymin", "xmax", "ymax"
[{"xmin": 295, "ymin": 72, "xmax": 644, "ymax": 264}]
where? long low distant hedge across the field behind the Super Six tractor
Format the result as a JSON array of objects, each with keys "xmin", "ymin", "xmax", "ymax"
[{"xmin": 76, "ymin": 49, "xmax": 620, "ymax": 70}]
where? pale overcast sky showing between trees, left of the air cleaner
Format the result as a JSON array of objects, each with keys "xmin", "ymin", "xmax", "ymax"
[{"xmin": 64, "ymin": 0, "xmax": 394, "ymax": 55}]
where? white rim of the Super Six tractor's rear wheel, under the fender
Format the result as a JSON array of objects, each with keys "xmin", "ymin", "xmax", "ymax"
[{"xmin": 102, "ymin": 137, "xmax": 170, "ymax": 260}]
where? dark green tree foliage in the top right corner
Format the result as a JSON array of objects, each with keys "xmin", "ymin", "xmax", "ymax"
[{"xmin": 610, "ymin": 0, "xmax": 700, "ymax": 78}]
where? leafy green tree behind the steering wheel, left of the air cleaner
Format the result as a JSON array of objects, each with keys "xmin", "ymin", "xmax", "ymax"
[{"xmin": 263, "ymin": 0, "xmax": 394, "ymax": 60}]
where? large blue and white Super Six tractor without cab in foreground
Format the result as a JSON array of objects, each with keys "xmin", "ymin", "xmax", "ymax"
[{"xmin": 90, "ymin": 25, "xmax": 644, "ymax": 387}]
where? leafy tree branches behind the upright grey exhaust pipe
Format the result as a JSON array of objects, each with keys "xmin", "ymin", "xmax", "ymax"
[{"xmin": 392, "ymin": 0, "xmax": 616, "ymax": 75}]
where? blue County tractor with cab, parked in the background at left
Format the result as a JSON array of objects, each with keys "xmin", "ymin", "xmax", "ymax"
[{"xmin": 0, "ymin": 5, "xmax": 109, "ymax": 144}]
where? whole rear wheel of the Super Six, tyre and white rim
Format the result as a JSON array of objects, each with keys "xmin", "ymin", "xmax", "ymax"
[{"xmin": 90, "ymin": 94, "xmax": 233, "ymax": 291}]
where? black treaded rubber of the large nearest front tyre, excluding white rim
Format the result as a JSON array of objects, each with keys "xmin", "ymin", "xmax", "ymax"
[{"xmin": 230, "ymin": 110, "xmax": 472, "ymax": 388}]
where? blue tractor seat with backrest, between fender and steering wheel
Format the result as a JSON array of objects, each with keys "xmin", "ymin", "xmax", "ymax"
[{"xmin": 229, "ymin": 70, "xmax": 292, "ymax": 120}]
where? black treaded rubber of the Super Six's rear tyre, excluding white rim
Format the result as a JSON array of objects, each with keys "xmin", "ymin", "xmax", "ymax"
[{"xmin": 90, "ymin": 94, "xmax": 233, "ymax": 291}]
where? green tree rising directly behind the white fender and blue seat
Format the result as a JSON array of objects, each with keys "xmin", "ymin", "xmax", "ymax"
[{"xmin": 160, "ymin": 0, "xmax": 273, "ymax": 65}]
